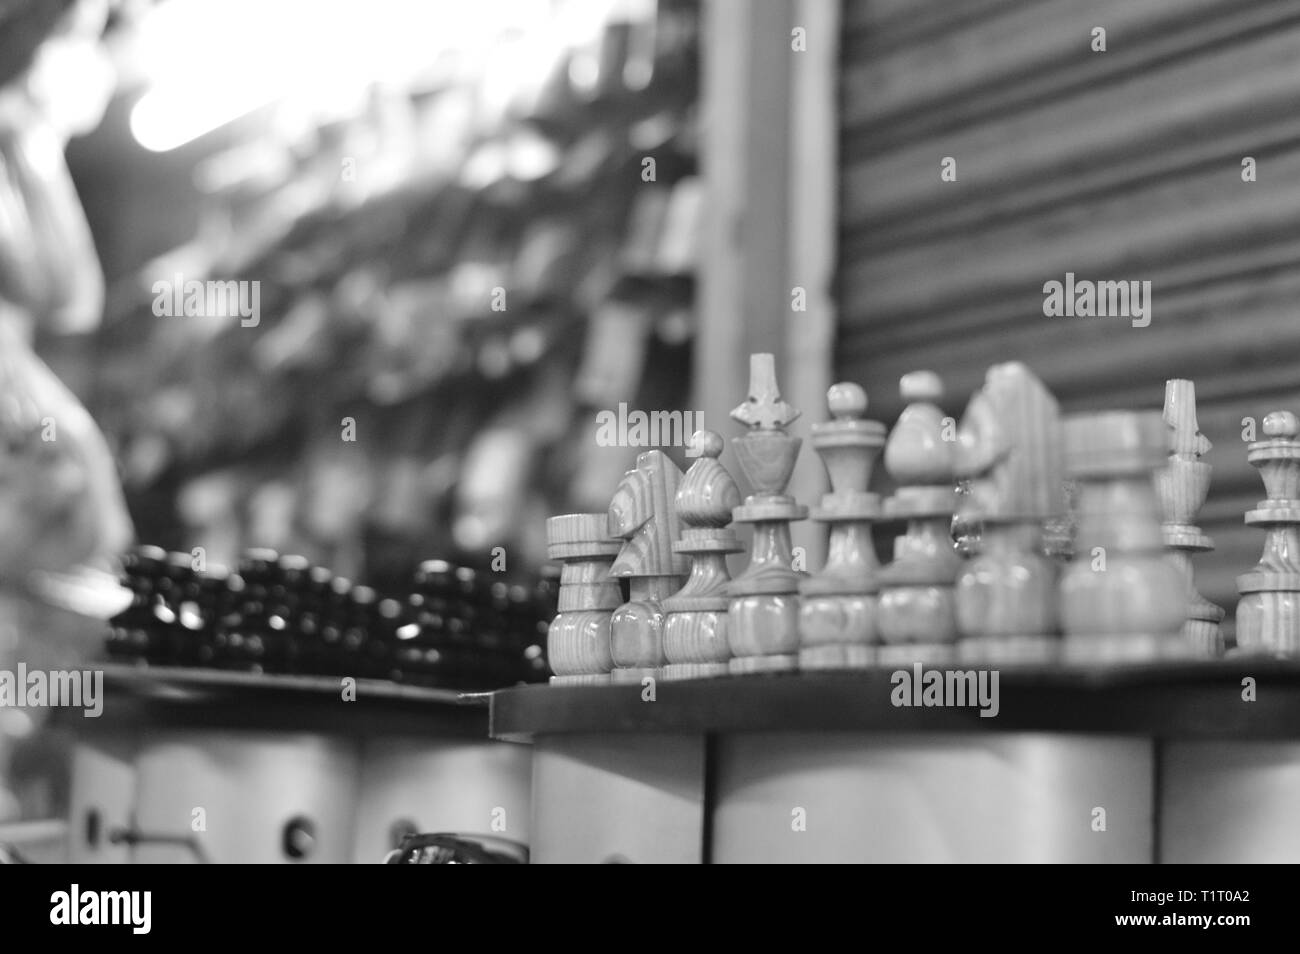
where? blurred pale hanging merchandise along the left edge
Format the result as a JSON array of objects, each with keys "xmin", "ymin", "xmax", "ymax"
[{"xmin": 0, "ymin": 3, "xmax": 131, "ymax": 638}]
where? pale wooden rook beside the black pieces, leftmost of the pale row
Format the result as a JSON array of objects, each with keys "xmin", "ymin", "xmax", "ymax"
[{"xmin": 546, "ymin": 513, "xmax": 623, "ymax": 685}]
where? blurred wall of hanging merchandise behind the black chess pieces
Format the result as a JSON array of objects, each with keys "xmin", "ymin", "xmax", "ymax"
[{"xmin": 77, "ymin": 0, "xmax": 701, "ymax": 582}]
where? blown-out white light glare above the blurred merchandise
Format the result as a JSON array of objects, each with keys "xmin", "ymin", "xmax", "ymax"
[{"xmin": 130, "ymin": 0, "xmax": 549, "ymax": 152}]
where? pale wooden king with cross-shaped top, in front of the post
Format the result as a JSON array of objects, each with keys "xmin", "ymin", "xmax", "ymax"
[{"xmin": 727, "ymin": 355, "xmax": 807, "ymax": 673}]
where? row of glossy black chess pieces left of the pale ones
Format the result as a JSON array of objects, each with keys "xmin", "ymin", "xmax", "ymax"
[{"xmin": 108, "ymin": 546, "xmax": 558, "ymax": 689}]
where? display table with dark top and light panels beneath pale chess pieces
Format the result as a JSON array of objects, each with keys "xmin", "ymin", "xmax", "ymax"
[{"xmin": 491, "ymin": 659, "xmax": 1300, "ymax": 863}]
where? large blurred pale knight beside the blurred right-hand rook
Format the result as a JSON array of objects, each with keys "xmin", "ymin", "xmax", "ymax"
[{"xmin": 957, "ymin": 361, "xmax": 1065, "ymax": 660}]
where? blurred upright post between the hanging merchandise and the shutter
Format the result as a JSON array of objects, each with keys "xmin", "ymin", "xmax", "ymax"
[{"xmin": 694, "ymin": 0, "xmax": 837, "ymax": 569}]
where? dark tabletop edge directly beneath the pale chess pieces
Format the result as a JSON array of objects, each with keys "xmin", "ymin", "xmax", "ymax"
[{"xmin": 491, "ymin": 658, "xmax": 1300, "ymax": 741}]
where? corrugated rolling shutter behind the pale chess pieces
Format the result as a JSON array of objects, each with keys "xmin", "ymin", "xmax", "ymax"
[{"xmin": 835, "ymin": 0, "xmax": 1300, "ymax": 624}]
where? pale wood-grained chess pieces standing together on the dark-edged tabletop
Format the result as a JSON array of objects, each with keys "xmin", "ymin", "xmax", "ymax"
[{"xmin": 546, "ymin": 354, "xmax": 1300, "ymax": 685}]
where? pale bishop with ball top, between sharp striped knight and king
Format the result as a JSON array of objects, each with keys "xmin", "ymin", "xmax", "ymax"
[{"xmin": 663, "ymin": 430, "xmax": 742, "ymax": 680}]
